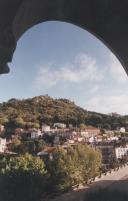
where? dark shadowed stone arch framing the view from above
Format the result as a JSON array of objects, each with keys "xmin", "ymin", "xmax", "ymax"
[{"xmin": 0, "ymin": 0, "xmax": 128, "ymax": 72}]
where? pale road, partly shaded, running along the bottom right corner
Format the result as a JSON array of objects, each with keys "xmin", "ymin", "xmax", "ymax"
[{"xmin": 49, "ymin": 166, "xmax": 128, "ymax": 201}]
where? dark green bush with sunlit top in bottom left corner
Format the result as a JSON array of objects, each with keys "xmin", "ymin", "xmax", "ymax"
[{"xmin": 0, "ymin": 154, "xmax": 46, "ymax": 201}]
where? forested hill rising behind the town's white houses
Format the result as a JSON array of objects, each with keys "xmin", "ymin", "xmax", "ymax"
[{"xmin": 0, "ymin": 95, "xmax": 128, "ymax": 129}]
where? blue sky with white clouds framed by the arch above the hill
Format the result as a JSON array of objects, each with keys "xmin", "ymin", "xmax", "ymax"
[{"xmin": 0, "ymin": 21, "xmax": 128, "ymax": 115}]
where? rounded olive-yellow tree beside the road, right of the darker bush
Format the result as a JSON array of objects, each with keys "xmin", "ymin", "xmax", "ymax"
[{"xmin": 46, "ymin": 145, "xmax": 101, "ymax": 192}]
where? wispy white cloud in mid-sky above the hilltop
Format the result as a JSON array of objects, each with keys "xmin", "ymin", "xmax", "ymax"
[{"xmin": 35, "ymin": 54, "xmax": 103, "ymax": 89}]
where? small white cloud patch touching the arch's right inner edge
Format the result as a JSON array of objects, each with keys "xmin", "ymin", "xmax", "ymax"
[{"xmin": 108, "ymin": 54, "xmax": 128, "ymax": 82}]
